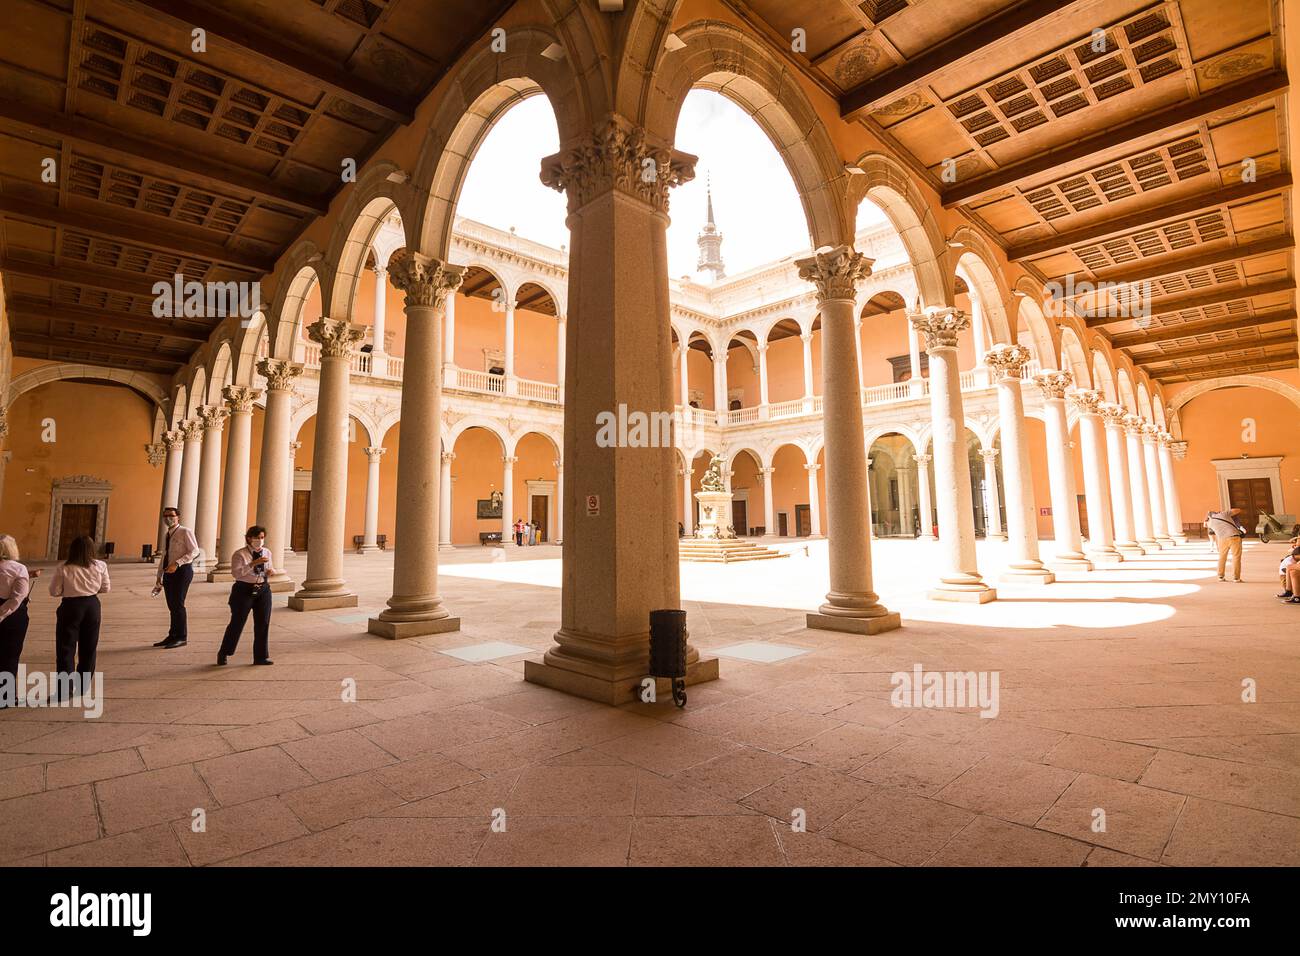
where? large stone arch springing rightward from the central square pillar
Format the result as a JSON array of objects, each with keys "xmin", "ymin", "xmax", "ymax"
[{"xmin": 647, "ymin": 20, "xmax": 857, "ymax": 247}]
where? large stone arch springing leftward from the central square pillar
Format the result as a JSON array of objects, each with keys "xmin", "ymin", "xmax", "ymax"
[{"xmin": 403, "ymin": 29, "xmax": 585, "ymax": 260}]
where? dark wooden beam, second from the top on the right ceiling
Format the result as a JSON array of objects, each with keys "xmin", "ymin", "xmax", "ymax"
[{"xmin": 941, "ymin": 72, "xmax": 1288, "ymax": 208}]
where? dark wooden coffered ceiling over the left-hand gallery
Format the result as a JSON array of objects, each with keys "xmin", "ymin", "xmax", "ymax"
[{"xmin": 0, "ymin": 0, "xmax": 512, "ymax": 373}]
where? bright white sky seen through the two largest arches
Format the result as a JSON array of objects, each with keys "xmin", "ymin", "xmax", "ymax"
[{"xmin": 456, "ymin": 90, "xmax": 883, "ymax": 277}]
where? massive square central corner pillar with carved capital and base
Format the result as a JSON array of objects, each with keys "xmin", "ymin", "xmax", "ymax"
[{"xmin": 524, "ymin": 114, "xmax": 718, "ymax": 704}]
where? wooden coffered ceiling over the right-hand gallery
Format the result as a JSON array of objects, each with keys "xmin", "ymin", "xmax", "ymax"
[{"xmin": 725, "ymin": 0, "xmax": 1296, "ymax": 382}]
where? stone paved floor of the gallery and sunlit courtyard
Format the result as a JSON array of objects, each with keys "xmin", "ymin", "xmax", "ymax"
[{"xmin": 0, "ymin": 541, "xmax": 1300, "ymax": 866}]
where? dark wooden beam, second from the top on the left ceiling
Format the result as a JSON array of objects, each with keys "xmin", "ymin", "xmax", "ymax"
[{"xmin": 0, "ymin": 99, "xmax": 329, "ymax": 216}]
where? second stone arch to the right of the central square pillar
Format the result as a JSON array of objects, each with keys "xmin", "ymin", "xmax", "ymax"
[{"xmin": 849, "ymin": 152, "xmax": 956, "ymax": 307}]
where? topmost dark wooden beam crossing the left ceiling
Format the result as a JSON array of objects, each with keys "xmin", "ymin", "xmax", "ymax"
[{"xmin": 118, "ymin": 0, "xmax": 415, "ymax": 126}]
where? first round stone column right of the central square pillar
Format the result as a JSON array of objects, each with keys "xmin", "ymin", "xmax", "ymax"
[{"xmin": 795, "ymin": 246, "xmax": 900, "ymax": 635}]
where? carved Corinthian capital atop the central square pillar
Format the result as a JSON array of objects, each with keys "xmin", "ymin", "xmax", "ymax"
[{"xmin": 541, "ymin": 116, "xmax": 698, "ymax": 213}]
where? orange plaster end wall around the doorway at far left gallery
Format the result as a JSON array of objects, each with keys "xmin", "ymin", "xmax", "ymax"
[{"xmin": 0, "ymin": 382, "xmax": 163, "ymax": 561}]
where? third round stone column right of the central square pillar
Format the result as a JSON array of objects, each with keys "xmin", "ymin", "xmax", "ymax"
[{"xmin": 984, "ymin": 345, "xmax": 1056, "ymax": 584}]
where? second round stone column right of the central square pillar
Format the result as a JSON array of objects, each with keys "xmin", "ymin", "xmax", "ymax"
[{"xmin": 907, "ymin": 306, "xmax": 997, "ymax": 604}]
